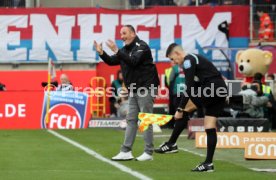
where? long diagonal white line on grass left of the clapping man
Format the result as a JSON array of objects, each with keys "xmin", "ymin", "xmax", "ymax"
[{"xmin": 47, "ymin": 130, "xmax": 152, "ymax": 180}]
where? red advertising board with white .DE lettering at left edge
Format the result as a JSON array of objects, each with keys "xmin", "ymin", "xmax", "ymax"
[{"xmin": 0, "ymin": 91, "xmax": 44, "ymax": 129}]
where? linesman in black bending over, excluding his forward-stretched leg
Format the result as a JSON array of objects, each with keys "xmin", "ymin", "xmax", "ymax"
[{"xmin": 167, "ymin": 43, "xmax": 227, "ymax": 172}]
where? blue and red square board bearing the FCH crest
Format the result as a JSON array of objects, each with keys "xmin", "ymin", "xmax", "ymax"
[{"xmin": 41, "ymin": 91, "xmax": 88, "ymax": 129}]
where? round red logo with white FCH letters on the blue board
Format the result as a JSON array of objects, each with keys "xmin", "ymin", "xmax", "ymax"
[{"xmin": 44, "ymin": 104, "xmax": 82, "ymax": 129}]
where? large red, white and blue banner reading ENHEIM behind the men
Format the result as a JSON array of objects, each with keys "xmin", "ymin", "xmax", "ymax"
[{"xmin": 0, "ymin": 6, "xmax": 249, "ymax": 65}]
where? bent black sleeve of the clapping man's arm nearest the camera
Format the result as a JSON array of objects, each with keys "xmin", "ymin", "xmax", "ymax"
[{"xmin": 116, "ymin": 44, "xmax": 150, "ymax": 67}]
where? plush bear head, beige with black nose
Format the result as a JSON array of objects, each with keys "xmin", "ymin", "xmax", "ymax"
[{"xmin": 236, "ymin": 48, "xmax": 272, "ymax": 77}]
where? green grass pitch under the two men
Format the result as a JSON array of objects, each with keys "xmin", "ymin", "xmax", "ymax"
[{"xmin": 0, "ymin": 129, "xmax": 276, "ymax": 180}]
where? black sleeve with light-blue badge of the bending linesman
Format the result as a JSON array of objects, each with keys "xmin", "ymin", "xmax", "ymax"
[{"xmin": 179, "ymin": 57, "xmax": 196, "ymax": 108}]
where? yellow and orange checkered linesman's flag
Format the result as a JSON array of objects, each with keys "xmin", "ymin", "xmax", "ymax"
[{"xmin": 138, "ymin": 113, "xmax": 173, "ymax": 132}]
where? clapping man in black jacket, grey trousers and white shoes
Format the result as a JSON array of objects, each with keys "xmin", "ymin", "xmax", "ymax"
[{"xmin": 94, "ymin": 25, "xmax": 159, "ymax": 161}]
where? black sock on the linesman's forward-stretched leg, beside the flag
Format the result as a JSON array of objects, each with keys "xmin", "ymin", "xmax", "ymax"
[{"xmin": 168, "ymin": 112, "xmax": 189, "ymax": 145}]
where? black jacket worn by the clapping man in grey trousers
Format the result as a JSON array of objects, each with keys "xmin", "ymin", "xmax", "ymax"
[{"xmin": 100, "ymin": 36, "xmax": 159, "ymax": 89}]
